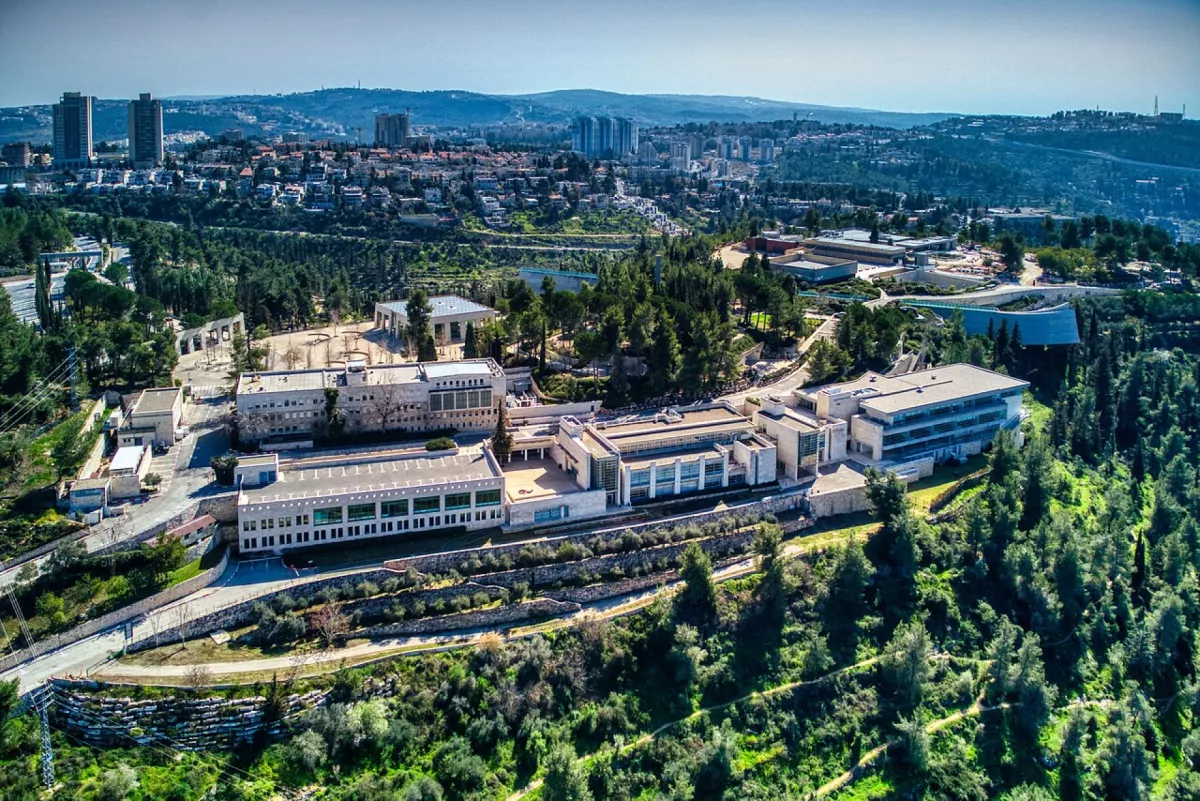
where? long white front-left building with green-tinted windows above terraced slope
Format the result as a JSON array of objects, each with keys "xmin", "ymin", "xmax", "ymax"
[{"xmin": 238, "ymin": 447, "xmax": 504, "ymax": 553}]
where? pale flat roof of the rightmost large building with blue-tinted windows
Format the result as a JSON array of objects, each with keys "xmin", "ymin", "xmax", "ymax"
[{"xmin": 817, "ymin": 363, "xmax": 1030, "ymax": 415}]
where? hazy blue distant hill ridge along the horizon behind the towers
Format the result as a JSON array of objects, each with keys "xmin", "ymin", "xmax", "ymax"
[{"xmin": 0, "ymin": 88, "xmax": 952, "ymax": 143}]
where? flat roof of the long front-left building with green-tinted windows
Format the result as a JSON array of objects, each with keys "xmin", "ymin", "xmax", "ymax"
[{"xmin": 241, "ymin": 452, "xmax": 502, "ymax": 504}]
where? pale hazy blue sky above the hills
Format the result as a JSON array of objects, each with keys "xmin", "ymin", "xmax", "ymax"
[{"xmin": 0, "ymin": 0, "xmax": 1200, "ymax": 116}]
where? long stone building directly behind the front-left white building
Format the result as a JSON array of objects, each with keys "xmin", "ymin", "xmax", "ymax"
[{"xmin": 236, "ymin": 359, "xmax": 505, "ymax": 447}]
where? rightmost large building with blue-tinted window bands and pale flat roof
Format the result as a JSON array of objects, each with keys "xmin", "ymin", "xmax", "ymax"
[{"xmin": 796, "ymin": 365, "xmax": 1028, "ymax": 464}]
